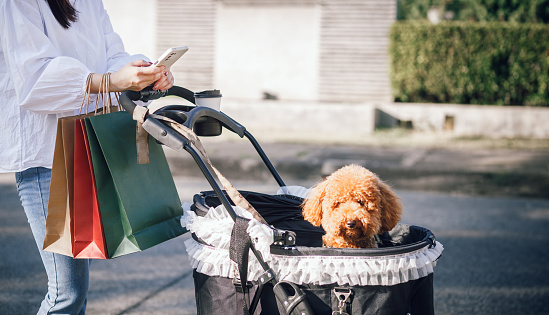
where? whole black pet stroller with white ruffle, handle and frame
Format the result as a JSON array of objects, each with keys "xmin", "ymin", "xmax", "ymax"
[{"xmin": 120, "ymin": 87, "xmax": 443, "ymax": 315}]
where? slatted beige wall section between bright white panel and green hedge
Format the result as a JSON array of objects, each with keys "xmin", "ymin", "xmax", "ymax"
[{"xmin": 319, "ymin": 0, "xmax": 396, "ymax": 102}]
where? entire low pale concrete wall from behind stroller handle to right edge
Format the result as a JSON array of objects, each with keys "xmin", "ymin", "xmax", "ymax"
[{"xmin": 222, "ymin": 100, "xmax": 549, "ymax": 143}]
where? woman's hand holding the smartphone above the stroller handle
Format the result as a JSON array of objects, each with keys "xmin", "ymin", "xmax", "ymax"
[{"xmin": 91, "ymin": 60, "xmax": 173, "ymax": 93}]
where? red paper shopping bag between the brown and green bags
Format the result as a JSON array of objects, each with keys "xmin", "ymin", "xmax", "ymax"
[{"xmin": 71, "ymin": 119, "xmax": 108, "ymax": 259}]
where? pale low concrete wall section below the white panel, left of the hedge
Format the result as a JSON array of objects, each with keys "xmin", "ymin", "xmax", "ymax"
[{"xmin": 221, "ymin": 99, "xmax": 375, "ymax": 143}]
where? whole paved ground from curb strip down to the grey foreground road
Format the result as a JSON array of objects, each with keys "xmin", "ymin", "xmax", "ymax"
[{"xmin": 0, "ymin": 139, "xmax": 549, "ymax": 314}]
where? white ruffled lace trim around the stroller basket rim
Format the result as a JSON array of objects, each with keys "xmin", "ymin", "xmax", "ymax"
[{"xmin": 181, "ymin": 190, "xmax": 444, "ymax": 286}]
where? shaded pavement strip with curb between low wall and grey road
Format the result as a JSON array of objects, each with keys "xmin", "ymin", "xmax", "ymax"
[{"xmin": 166, "ymin": 137, "xmax": 549, "ymax": 198}]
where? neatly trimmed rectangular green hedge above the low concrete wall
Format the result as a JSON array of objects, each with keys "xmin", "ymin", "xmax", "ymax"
[{"xmin": 390, "ymin": 21, "xmax": 549, "ymax": 106}]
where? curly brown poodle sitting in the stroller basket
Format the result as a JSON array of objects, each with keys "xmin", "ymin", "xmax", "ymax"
[{"xmin": 303, "ymin": 165, "xmax": 402, "ymax": 248}]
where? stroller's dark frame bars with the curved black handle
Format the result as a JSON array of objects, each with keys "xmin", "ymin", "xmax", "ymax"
[{"xmin": 120, "ymin": 86, "xmax": 313, "ymax": 315}]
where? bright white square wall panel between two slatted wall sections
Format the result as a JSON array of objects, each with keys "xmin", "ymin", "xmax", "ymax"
[{"xmin": 215, "ymin": 2, "xmax": 320, "ymax": 100}]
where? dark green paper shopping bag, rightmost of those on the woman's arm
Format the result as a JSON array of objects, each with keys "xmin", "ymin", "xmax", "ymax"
[{"xmin": 85, "ymin": 112, "xmax": 187, "ymax": 258}]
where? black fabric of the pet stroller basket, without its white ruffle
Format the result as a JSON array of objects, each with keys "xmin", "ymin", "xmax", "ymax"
[{"xmin": 191, "ymin": 191, "xmax": 434, "ymax": 315}]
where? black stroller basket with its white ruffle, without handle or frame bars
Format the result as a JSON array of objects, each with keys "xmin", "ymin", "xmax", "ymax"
[{"xmin": 182, "ymin": 191, "xmax": 443, "ymax": 314}]
